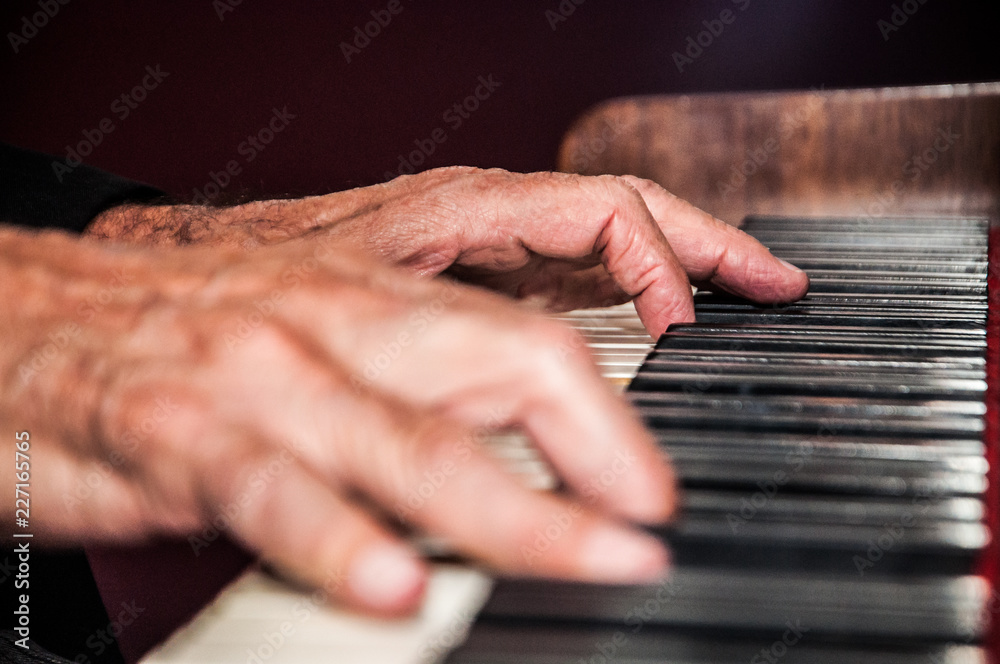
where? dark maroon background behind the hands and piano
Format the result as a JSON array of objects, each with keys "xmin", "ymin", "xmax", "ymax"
[{"xmin": 0, "ymin": 0, "xmax": 1000, "ymax": 660}]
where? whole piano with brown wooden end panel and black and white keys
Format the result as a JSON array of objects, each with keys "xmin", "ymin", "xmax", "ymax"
[{"xmin": 137, "ymin": 84, "xmax": 1000, "ymax": 664}]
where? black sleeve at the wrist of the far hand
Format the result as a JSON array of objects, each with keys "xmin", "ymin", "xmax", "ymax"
[{"xmin": 0, "ymin": 143, "xmax": 164, "ymax": 233}]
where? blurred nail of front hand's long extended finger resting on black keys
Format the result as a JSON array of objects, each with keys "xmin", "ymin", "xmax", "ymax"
[{"xmin": 581, "ymin": 526, "xmax": 670, "ymax": 583}]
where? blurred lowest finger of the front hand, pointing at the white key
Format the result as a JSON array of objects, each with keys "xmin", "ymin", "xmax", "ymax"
[{"xmin": 204, "ymin": 441, "xmax": 428, "ymax": 615}]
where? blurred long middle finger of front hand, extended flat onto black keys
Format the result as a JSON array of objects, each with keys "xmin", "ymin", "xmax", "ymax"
[{"xmin": 262, "ymin": 382, "xmax": 668, "ymax": 583}]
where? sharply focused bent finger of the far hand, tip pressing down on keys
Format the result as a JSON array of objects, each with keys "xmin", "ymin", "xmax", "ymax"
[{"xmin": 456, "ymin": 171, "xmax": 694, "ymax": 336}]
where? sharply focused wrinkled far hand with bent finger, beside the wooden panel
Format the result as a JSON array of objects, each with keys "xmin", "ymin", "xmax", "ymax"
[{"xmin": 84, "ymin": 167, "xmax": 808, "ymax": 336}]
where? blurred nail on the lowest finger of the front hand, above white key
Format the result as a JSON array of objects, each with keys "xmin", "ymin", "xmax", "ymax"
[{"xmin": 350, "ymin": 544, "xmax": 426, "ymax": 611}]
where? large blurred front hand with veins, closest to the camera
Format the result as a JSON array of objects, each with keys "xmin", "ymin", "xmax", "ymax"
[{"xmin": 0, "ymin": 227, "xmax": 675, "ymax": 614}]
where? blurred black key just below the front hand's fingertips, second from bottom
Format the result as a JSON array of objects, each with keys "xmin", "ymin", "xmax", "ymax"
[{"xmin": 481, "ymin": 565, "xmax": 988, "ymax": 641}]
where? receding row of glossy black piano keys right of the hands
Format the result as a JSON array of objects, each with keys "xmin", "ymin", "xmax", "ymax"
[{"xmin": 447, "ymin": 218, "xmax": 996, "ymax": 664}]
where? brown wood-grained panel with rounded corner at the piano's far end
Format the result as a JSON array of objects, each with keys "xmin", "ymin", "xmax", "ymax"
[{"xmin": 559, "ymin": 83, "xmax": 1000, "ymax": 228}]
